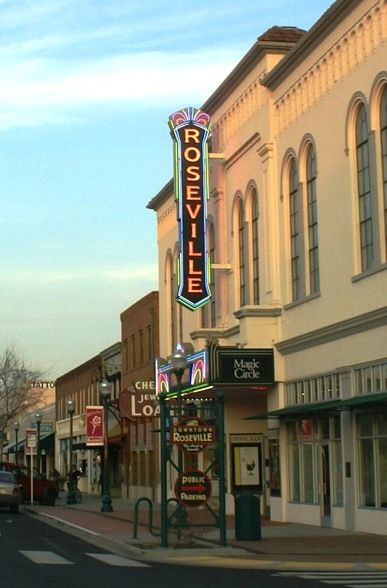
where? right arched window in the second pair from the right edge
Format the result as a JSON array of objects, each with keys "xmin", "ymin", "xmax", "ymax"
[{"xmin": 306, "ymin": 145, "xmax": 320, "ymax": 294}]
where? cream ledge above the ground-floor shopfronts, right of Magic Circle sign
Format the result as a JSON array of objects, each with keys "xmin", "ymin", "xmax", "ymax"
[{"xmin": 275, "ymin": 306, "xmax": 387, "ymax": 355}]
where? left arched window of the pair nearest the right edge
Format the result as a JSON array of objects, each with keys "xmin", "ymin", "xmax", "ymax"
[{"xmin": 356, "ymin": 104, "xmax": 374, "ymax": 271}]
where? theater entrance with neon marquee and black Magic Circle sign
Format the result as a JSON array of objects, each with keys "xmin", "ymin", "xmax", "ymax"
[{"xmin": 156, "ymin": 342, "xmax": 275, "ymax": 512}]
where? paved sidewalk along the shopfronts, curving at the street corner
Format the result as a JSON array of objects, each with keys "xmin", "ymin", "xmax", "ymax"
[{"xmin": 23, "ymin": 493, "xmax": 387, "ymax": 571}]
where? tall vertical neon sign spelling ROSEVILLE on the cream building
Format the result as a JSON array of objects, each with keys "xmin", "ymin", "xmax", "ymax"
[{"xmin": 169, "ymin": 107, "xmax": 211, "ymax": 310}]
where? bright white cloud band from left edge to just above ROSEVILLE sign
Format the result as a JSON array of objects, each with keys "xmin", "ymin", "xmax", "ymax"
[{"xmin": 0, "ymin": 50, "xmax": 241, "ymax": 129}]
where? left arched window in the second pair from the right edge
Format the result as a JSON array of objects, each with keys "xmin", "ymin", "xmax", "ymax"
[{"xmin": 289, "ymin": 159, "xmax": 304, "ymax": 301}]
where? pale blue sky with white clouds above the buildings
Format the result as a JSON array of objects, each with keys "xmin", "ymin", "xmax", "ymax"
[{"xmin": 0, "ymin": 0, "xmax": 332, "ymax": 380}]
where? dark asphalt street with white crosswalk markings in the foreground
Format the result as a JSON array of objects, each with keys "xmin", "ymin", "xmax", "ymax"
[{"xmin": 0, "ymin": 510, "xmax": 387, "ymax": 588}]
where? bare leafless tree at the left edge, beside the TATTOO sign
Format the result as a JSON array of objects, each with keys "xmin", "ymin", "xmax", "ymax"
[{"xmin": 0, "ymin": 347, "xmax": 41, "ymax": 455}]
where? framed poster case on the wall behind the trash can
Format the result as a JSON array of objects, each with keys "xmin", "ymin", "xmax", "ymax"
[{"xmin": 230, "ymin": 434, "xmax": 263, "ymax": 494}]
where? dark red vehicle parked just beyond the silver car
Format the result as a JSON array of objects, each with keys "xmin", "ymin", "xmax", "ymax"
[{"xmin": 0, "ymin": 461, "xmax": 58, "ymax": 506}]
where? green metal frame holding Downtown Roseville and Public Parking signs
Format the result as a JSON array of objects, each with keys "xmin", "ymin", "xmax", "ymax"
[{"xmin": 159, "ymin": 391, "xmax": 227, "ymax": 547}]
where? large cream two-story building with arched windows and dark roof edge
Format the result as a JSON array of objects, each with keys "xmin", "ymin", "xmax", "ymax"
[{"xmin": 148, "ymin": 0, "xmax": 387, "ymax": 534}]
